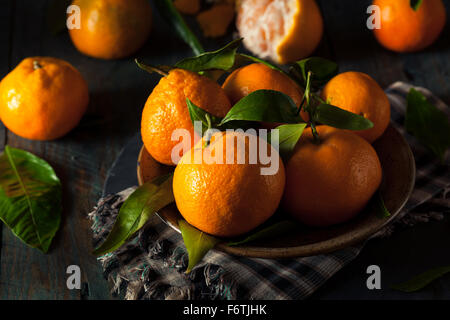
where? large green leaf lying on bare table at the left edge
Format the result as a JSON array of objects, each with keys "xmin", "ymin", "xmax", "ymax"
[{"xmin": 0, "ymin": 146, "xmax": 62, "ymax": 253}]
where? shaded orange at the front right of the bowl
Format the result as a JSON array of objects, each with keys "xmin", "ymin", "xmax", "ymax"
[{"xmin": 282, "ymin": 126, "xmax": 382, "ymax": 226}]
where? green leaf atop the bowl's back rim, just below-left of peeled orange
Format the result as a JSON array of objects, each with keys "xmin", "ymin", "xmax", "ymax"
[{"xmin": 175, "ymin": 39, "xmax": 242, "ymax": 72}]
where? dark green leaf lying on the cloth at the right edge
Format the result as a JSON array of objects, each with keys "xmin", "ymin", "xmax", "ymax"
[{"xmin": 405, "ymin": 88, "xmax": 450, "ymax": 161}]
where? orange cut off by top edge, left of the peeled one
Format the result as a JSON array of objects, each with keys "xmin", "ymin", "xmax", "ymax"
[{"xmin": 69, "ymin": 0, "xmax": 152, "ymax": 59}]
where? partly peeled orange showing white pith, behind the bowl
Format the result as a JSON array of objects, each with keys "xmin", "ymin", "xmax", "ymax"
[{"xmin": 236, "ymin": 0, "xmax": 323, "ymax": 64}]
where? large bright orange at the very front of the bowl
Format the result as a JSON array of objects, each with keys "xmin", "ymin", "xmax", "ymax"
[{"xmin": 173, "ymin": 132, "xmax": 285, "ymax": 237}]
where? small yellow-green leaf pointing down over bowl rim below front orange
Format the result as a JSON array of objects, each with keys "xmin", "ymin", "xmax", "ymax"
[{"xmin": 178, "ymin": 220, "xmax": 220, "ymax": 273}]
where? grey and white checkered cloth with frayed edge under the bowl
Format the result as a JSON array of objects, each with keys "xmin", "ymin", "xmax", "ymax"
[{"xmin": 89, "ymin": 82, "xmax": 450, "ymax": 300}]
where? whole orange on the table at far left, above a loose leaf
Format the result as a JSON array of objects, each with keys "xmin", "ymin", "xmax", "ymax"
[{"xmin": 0, "ymin": 57, "xmax": 89, "ymax": 140}]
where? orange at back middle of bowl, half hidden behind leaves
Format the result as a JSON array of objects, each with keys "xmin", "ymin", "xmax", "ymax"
[{"xmin": 222, "ymin": 63, "xmax": 308, "ymax": 120}]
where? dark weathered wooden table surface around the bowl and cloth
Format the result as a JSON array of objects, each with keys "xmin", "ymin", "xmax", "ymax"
[{"xmin": 0, "ymin": 0, "xmax": 450, "ymax": 299}]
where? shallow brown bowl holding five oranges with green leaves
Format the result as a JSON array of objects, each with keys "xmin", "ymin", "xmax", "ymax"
[{"xmin": 137, "ymin": 43, "xmax": 415, "ymax": 258}]
